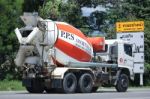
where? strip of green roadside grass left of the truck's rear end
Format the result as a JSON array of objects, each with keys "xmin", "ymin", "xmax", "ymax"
[{"xmin": 0, "ymin": 80, "xmax": 25, "ymax": 91}]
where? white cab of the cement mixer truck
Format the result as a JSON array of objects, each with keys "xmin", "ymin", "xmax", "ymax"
[{"xmin": 96, "ymin": 39, "xmax": 134, "ymax": 80}]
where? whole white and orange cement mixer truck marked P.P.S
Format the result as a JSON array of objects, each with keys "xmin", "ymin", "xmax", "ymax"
[{"xmin": 15, "ymin": 13, "xmax": 134, "ymax": 93}]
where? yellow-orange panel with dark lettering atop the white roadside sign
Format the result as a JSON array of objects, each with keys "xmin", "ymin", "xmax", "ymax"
[{"xmin": 116, "ymin": 21, "xmax": 144, "ymax": 32}]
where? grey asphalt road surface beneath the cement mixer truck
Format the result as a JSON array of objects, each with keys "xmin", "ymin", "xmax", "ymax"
[{"xmin": 0, "ymin": 88, "xmax": 150, "ymax": 99}]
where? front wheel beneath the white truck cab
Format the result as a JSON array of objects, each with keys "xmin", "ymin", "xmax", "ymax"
[{"xmin": 115, "ymin": 74, "xmax": 129, "ymax": 92}]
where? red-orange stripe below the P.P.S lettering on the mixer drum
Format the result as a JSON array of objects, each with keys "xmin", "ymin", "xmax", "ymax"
[{"xmin": 55, "ymin": 39, "xmax": 91, "ymax": 62}]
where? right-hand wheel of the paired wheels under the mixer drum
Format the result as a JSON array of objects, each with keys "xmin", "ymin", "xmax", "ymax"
[{"xmin": 79, "ymin": 73, "xmax": 93, "ymax": 93}]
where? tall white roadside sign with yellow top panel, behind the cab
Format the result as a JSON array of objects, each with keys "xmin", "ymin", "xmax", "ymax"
[{"xmin": 116, "ymin": 21, "xmax": 144, "ymax": 85}]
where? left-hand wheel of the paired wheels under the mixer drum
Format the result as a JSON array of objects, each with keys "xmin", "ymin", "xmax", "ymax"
[{"xmin": 63, "ymin": 73, "xmax": 77, "ymax": 93}]
